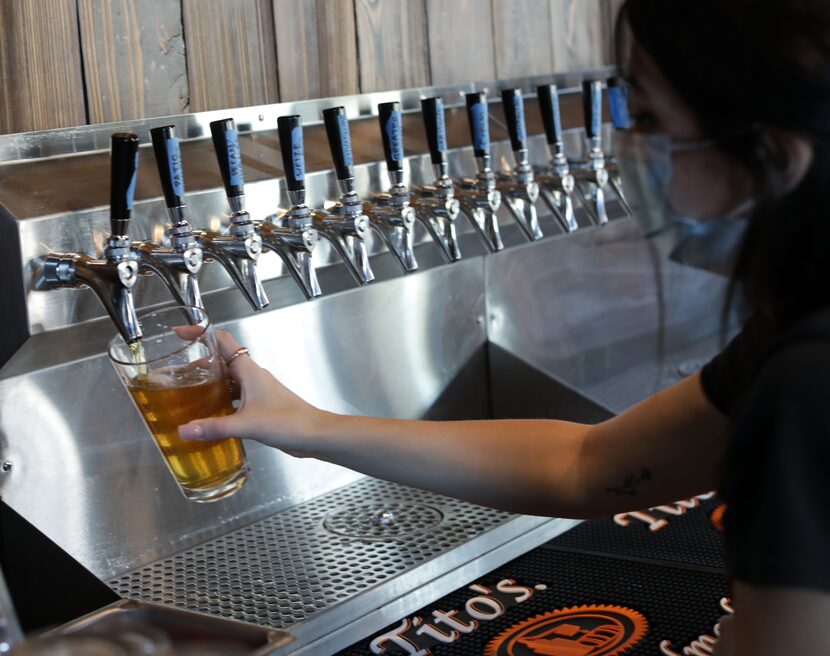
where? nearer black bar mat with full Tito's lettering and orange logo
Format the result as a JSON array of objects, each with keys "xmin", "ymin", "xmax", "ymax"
[{"xmin": 339, "ymin": 547, "xmax": 728, "ymax": 656}]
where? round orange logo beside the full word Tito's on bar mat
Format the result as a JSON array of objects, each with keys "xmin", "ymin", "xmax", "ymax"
[{"xmin": 484, "ymin": 606, "xmax": 648, "ymax": 656}]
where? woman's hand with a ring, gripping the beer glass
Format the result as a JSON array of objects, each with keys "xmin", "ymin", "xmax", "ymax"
[{"xmin": 179, "ymin": 330, "xmax": 328, "ymax": 456}]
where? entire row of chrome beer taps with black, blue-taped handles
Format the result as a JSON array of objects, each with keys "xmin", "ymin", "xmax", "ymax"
[{"xmin": 35, "ymin": 80, "xmax": 627, "ymax": 342}]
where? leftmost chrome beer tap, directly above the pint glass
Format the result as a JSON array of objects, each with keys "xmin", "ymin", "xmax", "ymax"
[{"xmin": 35, "ymin": 132, "xmax": 141, "ymax": 342}]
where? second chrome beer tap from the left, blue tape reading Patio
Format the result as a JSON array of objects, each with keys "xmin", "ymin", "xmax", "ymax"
[{"xmin": 132, "ymin": 125, "xmax": 204, "ymax": 307}]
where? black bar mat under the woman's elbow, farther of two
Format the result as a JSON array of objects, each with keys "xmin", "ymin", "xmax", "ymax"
[{"xmin": 547, "ymin": 498, "xmax": 726, "ymax": 570}]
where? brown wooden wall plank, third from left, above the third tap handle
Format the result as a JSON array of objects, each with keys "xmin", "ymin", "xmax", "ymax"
[{"xmin": 182, "ymin": 0, "xmax": 279, "ymax": 112}]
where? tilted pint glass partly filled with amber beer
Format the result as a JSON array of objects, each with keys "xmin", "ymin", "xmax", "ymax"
[{"xmin": 109, "ymin": 306, "xmax": 248, "ymax": 501}]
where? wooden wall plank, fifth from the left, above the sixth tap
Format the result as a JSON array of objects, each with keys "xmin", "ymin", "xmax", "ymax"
[{"xmin": 355, "ymin": 0, "xmax": 432, "ymax": 93}]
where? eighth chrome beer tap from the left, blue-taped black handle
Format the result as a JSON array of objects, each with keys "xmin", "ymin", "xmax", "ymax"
[{"xmin": 457, "ymin": 92, "xmax": 504, "ymax": 253}]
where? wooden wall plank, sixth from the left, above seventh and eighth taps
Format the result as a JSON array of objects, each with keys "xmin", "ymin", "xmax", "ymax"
[{"xmin": 427, "ymin": 0, "xmax": 496, "ymax": 85}]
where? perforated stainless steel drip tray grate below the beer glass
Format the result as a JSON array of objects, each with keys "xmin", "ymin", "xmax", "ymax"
[{"xmin": 109, "ymin": 478, "xmax": 515, "ymax": 629}]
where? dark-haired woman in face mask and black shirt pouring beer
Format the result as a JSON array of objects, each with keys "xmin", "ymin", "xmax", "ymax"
[{"xmin": 180, "ymin": 0, "xmax": 830, "ymax": 656}]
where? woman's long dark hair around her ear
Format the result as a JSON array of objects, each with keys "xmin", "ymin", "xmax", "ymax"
[{"xmin": 616, "ymin": 0, "xmax": 830, "ymax": 343}]
